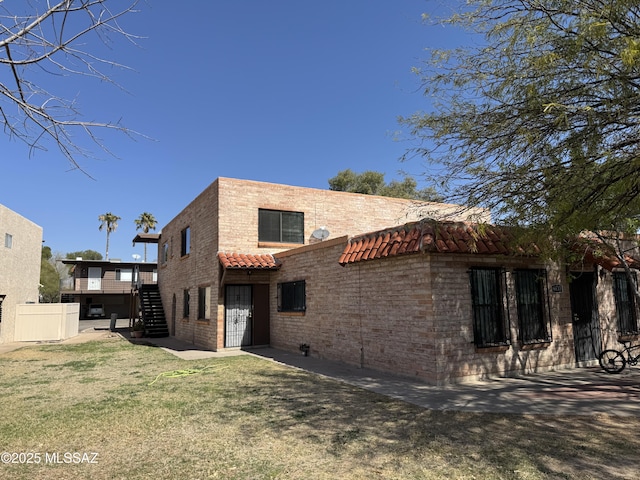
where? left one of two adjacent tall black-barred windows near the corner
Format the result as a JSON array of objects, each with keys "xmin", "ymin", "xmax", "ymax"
[{"xmin": 469, "ymin": 268, "xmax": 509, "ymax": 347}]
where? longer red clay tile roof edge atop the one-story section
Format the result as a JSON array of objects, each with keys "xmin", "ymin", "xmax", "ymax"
[{"xmin": 339, "ymin": 221, "xmax": 539, "ymax": 265}]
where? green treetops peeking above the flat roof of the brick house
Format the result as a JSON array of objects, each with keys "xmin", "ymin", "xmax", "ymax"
[{"xmin": 329, "ymin": 168, "xmax": 442, "ymax": 202}]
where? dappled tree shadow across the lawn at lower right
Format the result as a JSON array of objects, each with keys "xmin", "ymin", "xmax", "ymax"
[{"xmin": 221, "ymin": 362, "xmax": 640, "ymax": 478}]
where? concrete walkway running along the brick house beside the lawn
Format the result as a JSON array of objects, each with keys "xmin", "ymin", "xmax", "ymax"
[{"xmin": 0, "ymin": 329, "xmax": 640, "ymax": 417}]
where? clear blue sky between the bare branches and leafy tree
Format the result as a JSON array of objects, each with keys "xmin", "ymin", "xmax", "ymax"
[{"xmin": 0, "ymin": 0, "xmax": 457, "ymax": 261}]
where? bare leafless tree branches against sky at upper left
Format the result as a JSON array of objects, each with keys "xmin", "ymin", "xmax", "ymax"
[{"xmin": 0, "ymin": 0, "xmax": 140, "ymax": 171}]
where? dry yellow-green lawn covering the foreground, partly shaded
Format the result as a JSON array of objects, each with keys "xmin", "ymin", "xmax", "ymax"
[{"xmin": 0, "ymin": 337, "xmax": 640, "ymax": 480}]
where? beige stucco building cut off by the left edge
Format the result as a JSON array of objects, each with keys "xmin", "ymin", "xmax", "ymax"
[{"xmin": 0, "ymin": 205, "xmax": 42, "ymax": 343}]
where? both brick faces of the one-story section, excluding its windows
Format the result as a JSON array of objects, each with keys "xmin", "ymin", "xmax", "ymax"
[{"xmin": 271, "ymin": 239, "xmax": 592, "ymax": 384}]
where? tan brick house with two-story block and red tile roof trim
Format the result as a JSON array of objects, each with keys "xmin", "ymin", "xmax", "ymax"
[{"xmin": 159, "ymin": 178, "xmax": 638, "ymax": 384}]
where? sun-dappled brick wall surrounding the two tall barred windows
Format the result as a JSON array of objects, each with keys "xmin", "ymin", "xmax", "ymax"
[{"xmin": 431, "ymin": 255, "xmax": 575, "ymax": 383}]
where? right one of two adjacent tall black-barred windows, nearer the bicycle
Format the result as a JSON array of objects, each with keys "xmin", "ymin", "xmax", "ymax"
[{"xmin": 513, "ymin": 270, "xmax": 551, "ymax": 344}]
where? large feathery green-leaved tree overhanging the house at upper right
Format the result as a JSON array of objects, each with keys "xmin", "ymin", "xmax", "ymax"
[{"xmin": 400, "ymin": 0, "xmax": 640, "ymax": 262}]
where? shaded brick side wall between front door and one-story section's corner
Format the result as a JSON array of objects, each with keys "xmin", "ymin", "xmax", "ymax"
[{"xmin": 271, "ymin": 238, "xmax": 434, "ymax": 380}]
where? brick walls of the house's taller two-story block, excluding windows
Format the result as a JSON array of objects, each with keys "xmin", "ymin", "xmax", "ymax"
[{"xmin": 158, "ymin": 178, "xmax": 478, "ymax": 349}]
